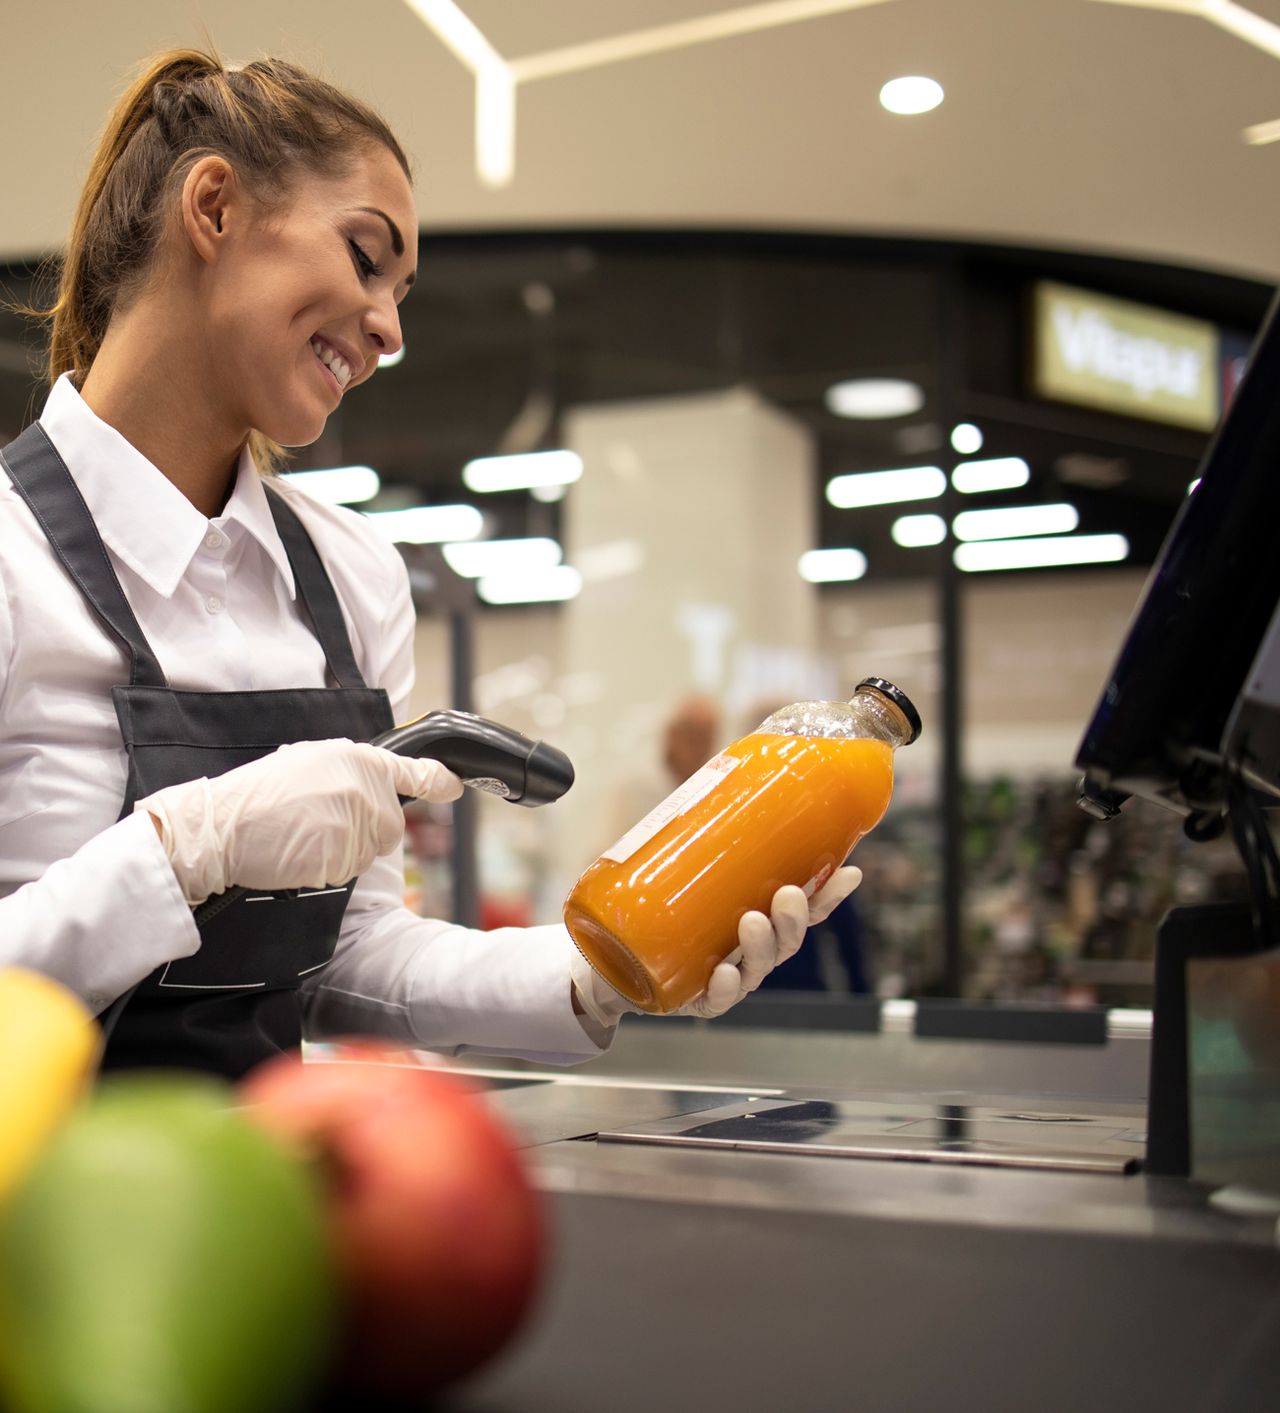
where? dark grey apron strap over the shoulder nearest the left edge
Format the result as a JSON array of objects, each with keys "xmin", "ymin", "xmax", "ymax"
[{"xmin": 0, "ymin": 422, "xmax": 168, "ymax": 687}]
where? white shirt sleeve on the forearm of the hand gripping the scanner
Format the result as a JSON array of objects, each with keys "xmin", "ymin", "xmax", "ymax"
[{"xmin": 0, "ymin": 814, "xmax": 201, "ymax": 1015}]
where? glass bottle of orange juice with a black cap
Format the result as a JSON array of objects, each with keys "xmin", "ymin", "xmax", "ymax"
[{"xmin": 564, "ymin": 677, "xmax": 920, "ymax": 1012}]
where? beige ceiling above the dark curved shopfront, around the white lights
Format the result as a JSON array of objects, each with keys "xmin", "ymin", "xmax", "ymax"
[{"xmin": 0, "ymin": 0, "xmax": 1280, "ymax": 277}]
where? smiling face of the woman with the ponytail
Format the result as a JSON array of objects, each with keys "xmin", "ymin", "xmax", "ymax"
[{"xmin": 202, "ymin": 144, "xmax": 418, "ymax": 447}]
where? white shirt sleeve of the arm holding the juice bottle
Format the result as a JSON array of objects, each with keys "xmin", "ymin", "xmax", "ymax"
[{"xmin": 302, "ymin": 534, "xmax": 612, "ymax": 1064}]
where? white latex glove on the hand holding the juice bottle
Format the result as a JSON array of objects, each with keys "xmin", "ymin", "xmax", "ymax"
[{"xmin": 569, "ymin": 865, "xmax": 862, "ymax": 1043}]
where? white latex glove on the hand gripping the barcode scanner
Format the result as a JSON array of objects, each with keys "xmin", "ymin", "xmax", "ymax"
[{"xmin": 133, "ymin": 739, "xmax": 462, "ymax": 907}]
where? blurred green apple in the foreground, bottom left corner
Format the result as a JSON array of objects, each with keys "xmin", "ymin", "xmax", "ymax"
[{"xmin": 0, "ymin": 1074, "xmax": 336, "ymax": 1413}]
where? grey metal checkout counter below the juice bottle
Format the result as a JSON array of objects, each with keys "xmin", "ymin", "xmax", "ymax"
[{"xmin": 441, "ymin": 1002, "xmax": 1280, "ymax": 1413}]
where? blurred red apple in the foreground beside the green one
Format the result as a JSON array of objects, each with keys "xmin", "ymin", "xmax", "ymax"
[{"xmin": 240, "ymin": 1041, "xmax": 544, "ymax": 1397}]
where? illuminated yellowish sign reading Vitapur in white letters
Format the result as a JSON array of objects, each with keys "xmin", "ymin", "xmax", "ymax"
[{"xmin": 1031, "ymin": 281, "xmax": 1219, "ymax": 431}]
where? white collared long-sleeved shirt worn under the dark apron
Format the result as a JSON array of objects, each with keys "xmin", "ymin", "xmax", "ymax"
[{"xmin": 0, "ymin": 376, "xmax": 599, "ymax": 1063}]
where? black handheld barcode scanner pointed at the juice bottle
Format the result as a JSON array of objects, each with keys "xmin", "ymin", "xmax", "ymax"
[{"xmin": 372, "ymin": 711, "xmax": 574, "ymax": 807}]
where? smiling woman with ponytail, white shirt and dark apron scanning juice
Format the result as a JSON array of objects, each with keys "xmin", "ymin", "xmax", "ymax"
[{"xmin": 0, "ymin": 51, "xmax": 830, "ymax": 1075}]
